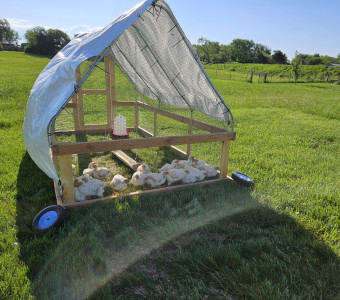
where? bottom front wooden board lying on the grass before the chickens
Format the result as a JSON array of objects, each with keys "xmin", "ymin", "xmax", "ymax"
[{"xmin": 64, "ymin": 177, "xmax": 233, "ymax": 207}]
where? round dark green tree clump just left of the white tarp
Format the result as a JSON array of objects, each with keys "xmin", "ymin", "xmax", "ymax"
[{"xmin": 25, "ymin": 26, "xmax": 70, "ymax": 55}]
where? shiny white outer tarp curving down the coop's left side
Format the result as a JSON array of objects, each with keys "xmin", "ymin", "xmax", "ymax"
[{"xmin": 23, "ymin": 0, "xmax": 152, "ymax": 181}]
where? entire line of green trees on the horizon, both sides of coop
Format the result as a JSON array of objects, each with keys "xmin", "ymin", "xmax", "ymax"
[{"xmin": 0, "ymin": 19, "xmax": 340, "ymax": 65}]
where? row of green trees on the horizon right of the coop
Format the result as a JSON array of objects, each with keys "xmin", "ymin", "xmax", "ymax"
[{"xmin": 193, "ymin": 37, "xmax": 340, "ymax": 65}]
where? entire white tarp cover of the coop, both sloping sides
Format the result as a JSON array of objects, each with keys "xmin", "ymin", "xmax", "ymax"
[{"xmin": 23, "ymin": 0, "xmax": 230, "ymax": 180}]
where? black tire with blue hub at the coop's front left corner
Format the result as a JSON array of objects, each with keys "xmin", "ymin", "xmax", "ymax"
[{"xmin": 32, "ymin": 205, "xmax": 66, "ymax": 233}]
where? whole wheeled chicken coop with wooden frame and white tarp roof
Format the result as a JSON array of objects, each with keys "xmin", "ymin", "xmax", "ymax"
[{"xmin": 23, "ymin": 0, "xmax": 253, "ymax": 232}]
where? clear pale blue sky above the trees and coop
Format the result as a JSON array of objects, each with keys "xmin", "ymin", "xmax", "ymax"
[{"xmin": 0, "ymin": 0, "xmax": 340, "ymax": 59}]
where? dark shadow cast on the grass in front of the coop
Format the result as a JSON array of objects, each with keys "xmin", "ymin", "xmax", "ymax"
[{"xmin": 17, "ymin": 154, "xmax": 340, "ymax": 299}]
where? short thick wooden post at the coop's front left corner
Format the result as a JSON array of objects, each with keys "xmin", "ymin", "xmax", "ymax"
[{"xmin": 58, "ymin": 154, "xmax": 75, "ymax": 204}]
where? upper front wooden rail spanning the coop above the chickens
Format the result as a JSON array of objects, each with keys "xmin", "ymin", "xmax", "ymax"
[{"xmin": 52, "ymin": 131, "xmax": 236, "ymax": 155}]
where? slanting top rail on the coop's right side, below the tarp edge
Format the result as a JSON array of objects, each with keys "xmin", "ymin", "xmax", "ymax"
[{"xmin": 138, "ymin": 102, "xmax": 228, "ymax": 133}]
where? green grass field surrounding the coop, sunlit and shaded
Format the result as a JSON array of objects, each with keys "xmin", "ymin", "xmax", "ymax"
[{"xmin": 0, "ymin": 52, "xmax": 340, "ymax": 300}]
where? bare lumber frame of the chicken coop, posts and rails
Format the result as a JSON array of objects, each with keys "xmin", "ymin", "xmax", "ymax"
[{"xmin": 51, "ymin": 56, "xmax": 236, "ymax": 206}]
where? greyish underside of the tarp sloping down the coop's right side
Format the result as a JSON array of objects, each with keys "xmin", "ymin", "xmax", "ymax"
[{"xmin": 111, "ymin": 1, "xmax": 229, "ymax": 121}]
